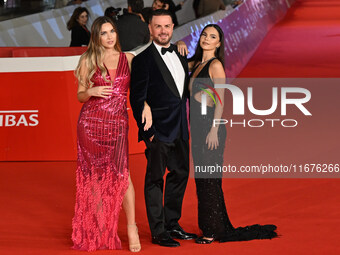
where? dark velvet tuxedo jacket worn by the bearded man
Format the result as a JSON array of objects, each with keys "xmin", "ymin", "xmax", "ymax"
[{"xmin": 130, "ymin": 43, "xmax": 189, "ymax": 142}]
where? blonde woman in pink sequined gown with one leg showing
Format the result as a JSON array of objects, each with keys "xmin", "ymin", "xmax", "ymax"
[{"xmin": 72, "ymin": 17, "xmax": 151, "ymax": 252}]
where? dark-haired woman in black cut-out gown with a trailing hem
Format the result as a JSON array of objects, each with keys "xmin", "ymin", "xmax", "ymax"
[{"xmin": 189, "ymin": 24, "xmax": 277, "ymax": 244}]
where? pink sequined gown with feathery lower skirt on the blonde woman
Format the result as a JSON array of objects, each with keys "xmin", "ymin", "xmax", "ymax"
[{"xmin": 72, "ymin": 53, "xmax": 130, "ymax": 251}]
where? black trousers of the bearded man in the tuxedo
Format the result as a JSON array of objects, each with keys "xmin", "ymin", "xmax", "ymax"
[{"xmin": 144, "ymin": 137, "xmax": 189, "ymax": 237}]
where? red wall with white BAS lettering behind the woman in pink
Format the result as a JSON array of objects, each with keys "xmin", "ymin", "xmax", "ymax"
[{"xmin": 0, "ymin": 71, "xmax": 144, "ymax": 161}]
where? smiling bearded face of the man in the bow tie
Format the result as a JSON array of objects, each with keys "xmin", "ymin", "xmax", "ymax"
[{"xmin": 149, "ymin": 15, "xmax": 174, "ymax": 46}]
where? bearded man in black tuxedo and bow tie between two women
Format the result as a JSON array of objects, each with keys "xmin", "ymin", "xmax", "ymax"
[{"xmin": 130, "ymin": 9, "xmax": 196, "ymax": 247}]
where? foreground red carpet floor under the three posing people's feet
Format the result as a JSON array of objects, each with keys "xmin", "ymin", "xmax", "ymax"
[{"xmin": 0, "ymin": 158, "xmax": 340, "ymax": 255}]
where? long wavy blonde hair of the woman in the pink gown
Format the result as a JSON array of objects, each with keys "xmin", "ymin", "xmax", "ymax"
[{"xmin": 75, "ymin": 16, "xmax": 122, "ymax": 88}]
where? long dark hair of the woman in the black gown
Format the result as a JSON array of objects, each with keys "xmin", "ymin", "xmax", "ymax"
[{"xmin": 189, "ymin": 24, "xmax": 224, "ymax": 67}]
